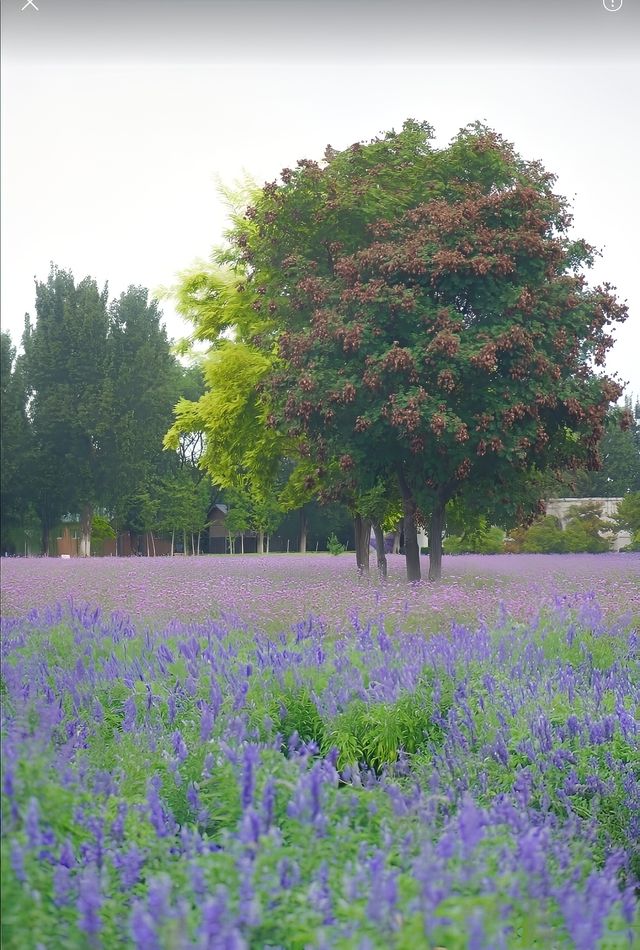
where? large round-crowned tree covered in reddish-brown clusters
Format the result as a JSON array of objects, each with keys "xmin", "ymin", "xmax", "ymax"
[{"xmin": 229, "ymin": 121, "xmax": 626, "ymax": 580}]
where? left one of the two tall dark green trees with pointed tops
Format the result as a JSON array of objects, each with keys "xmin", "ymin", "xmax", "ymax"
[{"xmin": 22, "ymin": 265, "xmax": 111, "ymax": 556}]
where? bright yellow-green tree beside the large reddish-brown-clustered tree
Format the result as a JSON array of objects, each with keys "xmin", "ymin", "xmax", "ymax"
[{"xmin": 164, "ymin": 258, "xmax": 308, "ymax": 537}]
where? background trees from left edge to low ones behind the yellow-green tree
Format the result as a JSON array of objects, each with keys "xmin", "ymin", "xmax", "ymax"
[{"xmin": 0, "ymin": 265, "xmax": 351, "ymax": 556}]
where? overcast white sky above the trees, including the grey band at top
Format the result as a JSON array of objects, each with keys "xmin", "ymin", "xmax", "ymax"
[{"xmin": 1, "ymin": 0, "xmax": 640, "ymax": 394}]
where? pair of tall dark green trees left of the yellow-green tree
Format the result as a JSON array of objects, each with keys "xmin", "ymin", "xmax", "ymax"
[{"xmin": 23, "ymin": 265, "xmax": 184, "ymax": 556}]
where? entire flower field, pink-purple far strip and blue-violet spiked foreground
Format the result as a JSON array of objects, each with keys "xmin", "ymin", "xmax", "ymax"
[{"xmin": 0, "ymin": 555, "xmax": 640, "ymax": 950}]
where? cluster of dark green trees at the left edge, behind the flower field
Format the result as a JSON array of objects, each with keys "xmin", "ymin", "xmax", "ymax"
[{"xmin": 1, "ymin": 265, "xmax": 209, "ymax": 555}]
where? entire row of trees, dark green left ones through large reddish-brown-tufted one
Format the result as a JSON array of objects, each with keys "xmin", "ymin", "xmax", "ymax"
[{"xmin": 2, "ymin": 120, "xmax": 640, "ymax": 580}]
